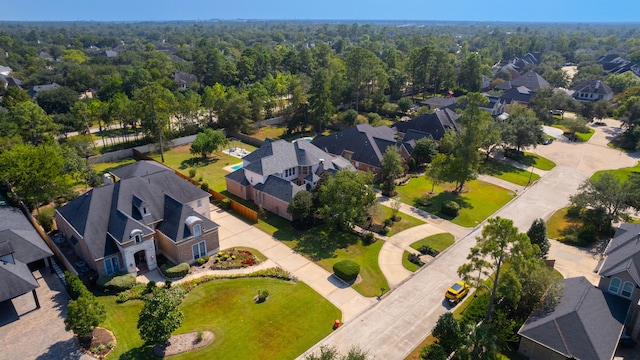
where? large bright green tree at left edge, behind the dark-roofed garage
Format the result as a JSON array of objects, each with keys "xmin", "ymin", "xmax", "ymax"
[{"xmin": 0, "ymin": 144, "xmax": 69, "ymax": 209}]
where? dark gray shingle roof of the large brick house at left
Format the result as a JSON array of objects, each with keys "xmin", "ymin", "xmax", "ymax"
[{"xmin": 58, "ymin": 162, "xmax": 217, "ymax": 260}]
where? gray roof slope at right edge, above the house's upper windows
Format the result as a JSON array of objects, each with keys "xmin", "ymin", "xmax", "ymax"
[{"xmin": 598, "ymin": 224, "xmax": 640, "ymax": 286}]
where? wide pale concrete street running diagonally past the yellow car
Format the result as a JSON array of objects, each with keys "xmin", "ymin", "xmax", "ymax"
[{"xmin": 299, "ymin": 120, "xmax": 637, "ymax": 359}]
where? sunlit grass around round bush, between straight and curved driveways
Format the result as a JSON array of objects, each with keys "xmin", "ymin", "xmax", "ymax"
[{"xmin": 316, "ymin": 240, "xmax": 389, "ymax": 297}]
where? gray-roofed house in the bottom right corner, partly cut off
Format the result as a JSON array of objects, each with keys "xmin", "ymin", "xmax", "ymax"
[{"xmin": 518, "ymin": 224, "xmax": 640, "ymax": 360}]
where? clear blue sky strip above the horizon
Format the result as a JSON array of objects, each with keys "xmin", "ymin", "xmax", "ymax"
[{"xmin": 0, "ymin": 0, "xmax": 640, "ymax": 23}]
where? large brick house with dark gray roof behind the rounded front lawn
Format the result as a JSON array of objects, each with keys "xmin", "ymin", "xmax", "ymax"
[{"xmin": 55, "ymin": 161, "xmax": 220, "ymax": 275}]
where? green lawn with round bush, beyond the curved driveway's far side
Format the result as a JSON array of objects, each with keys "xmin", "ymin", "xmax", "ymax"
[{"xmin": 396, "ymin": 176, "xmax": 516, "ymax": 227}]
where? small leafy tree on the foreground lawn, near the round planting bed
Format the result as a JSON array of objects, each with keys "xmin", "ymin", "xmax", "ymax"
[{"xmin": 138, "ymin": 288, "xmax": 184, "ymax": 344}]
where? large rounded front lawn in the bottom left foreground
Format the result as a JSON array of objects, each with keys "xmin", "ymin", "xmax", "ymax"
[{"xmin": 100, "ymin": 278, "xmax": 341, "ymax": 360}]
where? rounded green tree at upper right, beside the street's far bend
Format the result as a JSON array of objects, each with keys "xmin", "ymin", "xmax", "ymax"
[{"xmin": 502, "ymin": 106, "xmax": 544, "ymax": 151}]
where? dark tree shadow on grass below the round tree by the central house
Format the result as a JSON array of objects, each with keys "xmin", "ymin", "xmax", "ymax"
[{"xmin": 294, "ymin": 225, "xmax": 359, "ymax": 261}]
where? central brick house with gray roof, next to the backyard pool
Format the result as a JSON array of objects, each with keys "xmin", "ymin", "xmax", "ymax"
[{"xmin": 225, "ymin": 139, "xmax": 353, "ymax": 220}]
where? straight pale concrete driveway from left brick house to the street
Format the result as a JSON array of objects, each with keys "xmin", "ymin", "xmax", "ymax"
[{"xmin": 211, "ymin": 207, "xmax": 377, "ymax": 323}]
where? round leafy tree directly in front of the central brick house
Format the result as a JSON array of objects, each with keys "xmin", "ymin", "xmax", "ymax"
[{"xmin": 318, "ymin": 170, "xmax": 376, "ymax": 229}]
